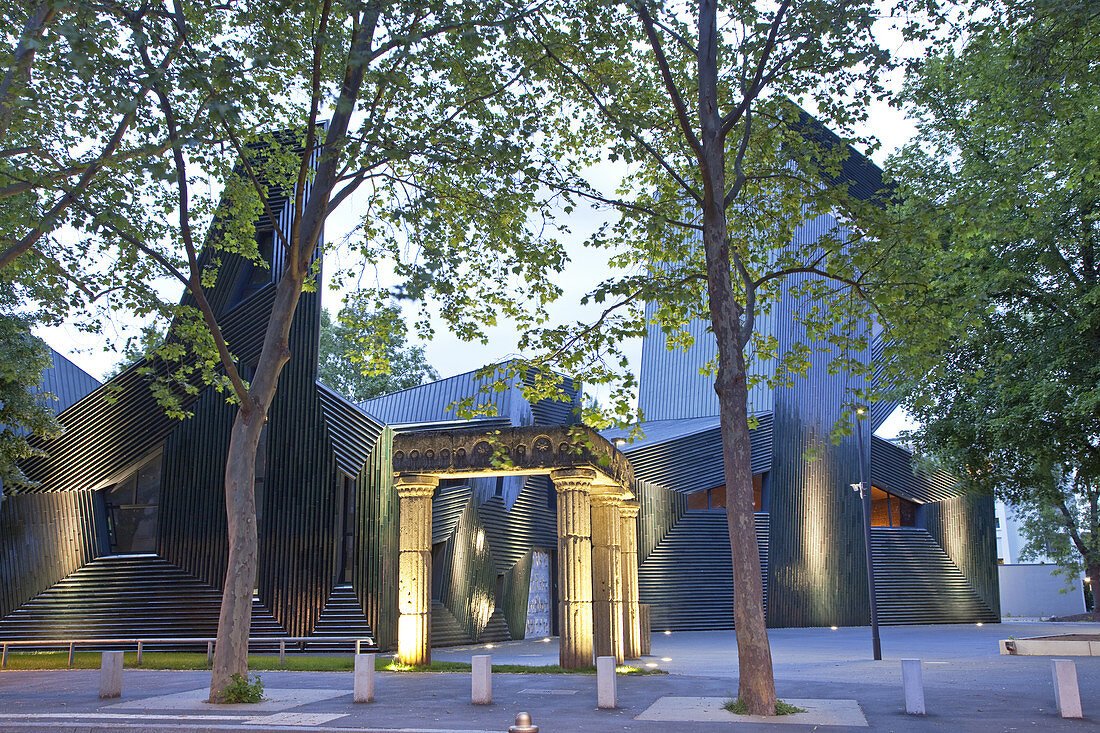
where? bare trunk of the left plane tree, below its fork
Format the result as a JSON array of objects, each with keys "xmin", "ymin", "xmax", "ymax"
[{"xmin": 210, "ymin": 408, "xmax": 266, "ymax": 702}]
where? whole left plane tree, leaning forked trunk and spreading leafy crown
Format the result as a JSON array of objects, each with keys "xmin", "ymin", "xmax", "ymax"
[{"xmin": 0, "ymin": 0, "xmax": 560, "ymax": 701}]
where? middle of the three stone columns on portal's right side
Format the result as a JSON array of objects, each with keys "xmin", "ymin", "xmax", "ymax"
[{"xmin": 592, "ymin": 489, "xmax": 624, "ymax": 664}]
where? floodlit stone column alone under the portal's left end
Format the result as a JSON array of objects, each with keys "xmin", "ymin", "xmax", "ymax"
[{"xmin": 394, "ymin": 473, "xmax": 439, "ymax": 666}]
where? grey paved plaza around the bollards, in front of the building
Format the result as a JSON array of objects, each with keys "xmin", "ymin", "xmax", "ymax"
[{"xmin": 0, "ymin": 623, "xmax": 1100, "ymax": 733}]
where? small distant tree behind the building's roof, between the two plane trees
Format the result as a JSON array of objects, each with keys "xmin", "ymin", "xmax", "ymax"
[{"xmin": 318, "ymin": 302, "xmax": 439, "ymax": 402}]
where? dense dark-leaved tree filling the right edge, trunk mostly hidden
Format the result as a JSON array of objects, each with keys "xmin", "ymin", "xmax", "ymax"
[{"xmin": 892, "ymin": 0, "xmax": 1100, "ymax": 620}]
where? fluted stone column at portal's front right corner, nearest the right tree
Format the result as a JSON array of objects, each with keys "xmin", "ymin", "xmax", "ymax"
[{"xmin": 550, "ymin": 469, "xmax": 596, "ymax": 669}]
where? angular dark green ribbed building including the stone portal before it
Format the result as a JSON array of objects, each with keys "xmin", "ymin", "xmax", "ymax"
[{"xmin": 0, "ymin": 144, "xmax": 999, "ymax": 664}]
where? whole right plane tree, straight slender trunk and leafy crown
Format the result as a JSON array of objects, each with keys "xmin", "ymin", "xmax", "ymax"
[{"xmin": 378, "ymin": 0, "xmax": 919, "ymax": 714}]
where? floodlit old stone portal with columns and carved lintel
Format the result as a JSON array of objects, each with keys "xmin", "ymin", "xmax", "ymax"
[{"xmin": 393, "ymin": 426, "xmax": 640, "ymax": 668}]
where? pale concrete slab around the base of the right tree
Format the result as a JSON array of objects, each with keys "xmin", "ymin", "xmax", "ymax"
[{"xmin": 635, "ymin": 697, "xmax": 867, "ymax": 727}]
